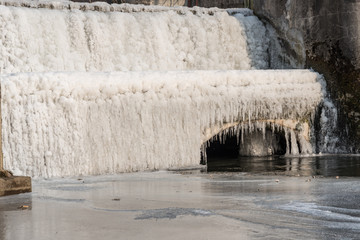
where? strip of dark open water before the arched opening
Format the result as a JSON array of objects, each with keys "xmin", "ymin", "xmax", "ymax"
[{"xmin": 207, "ymin": 155, "xmax": 360, "ymax": 177}]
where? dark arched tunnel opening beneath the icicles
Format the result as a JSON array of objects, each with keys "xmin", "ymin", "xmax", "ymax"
[{"xmin": 202, "ymin": 129, "xmax": 287, "ymax": 172}]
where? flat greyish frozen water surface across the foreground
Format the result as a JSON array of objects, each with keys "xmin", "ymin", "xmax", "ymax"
[{"xmin": 0, "ymin": 164, "xmax": 360, "ymax": 240}]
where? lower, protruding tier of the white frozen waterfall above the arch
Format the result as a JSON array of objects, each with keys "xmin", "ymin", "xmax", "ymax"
[{"xmin": 1, "ymin": 70, "xmax": 323, "ymax": 177}]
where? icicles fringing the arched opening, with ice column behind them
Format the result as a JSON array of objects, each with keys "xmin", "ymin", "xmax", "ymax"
[{"xmin": 201, "ymin": 119, "xmax": 315, "ymax": 162}]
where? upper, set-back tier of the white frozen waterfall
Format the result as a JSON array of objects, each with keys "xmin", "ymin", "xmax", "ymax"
[{"xmin": 0, "ymin": 1, "xmax": 268, "ymax": 73}]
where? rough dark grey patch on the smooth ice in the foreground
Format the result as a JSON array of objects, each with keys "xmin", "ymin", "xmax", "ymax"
[{"xmin": 135, "ymin": 208, "xmax": 214, "ymax": 220}]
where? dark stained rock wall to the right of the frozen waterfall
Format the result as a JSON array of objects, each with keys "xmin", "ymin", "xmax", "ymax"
[{"xmin": 247, "ymin": 0, "xmax": 360, "ymax": 152}]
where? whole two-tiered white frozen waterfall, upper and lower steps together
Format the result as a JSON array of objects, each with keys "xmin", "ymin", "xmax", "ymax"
[{"xmin": 0, "ymin": 0, "xmax": 330, "ymax": 177}]
